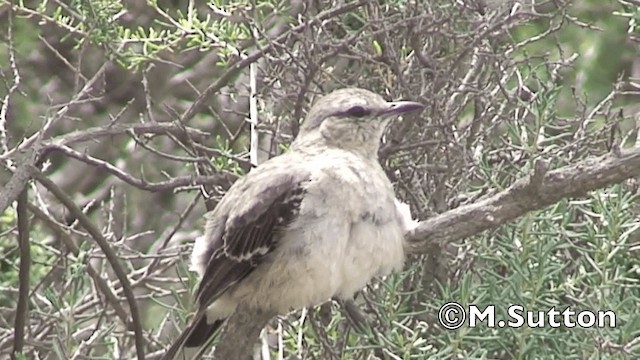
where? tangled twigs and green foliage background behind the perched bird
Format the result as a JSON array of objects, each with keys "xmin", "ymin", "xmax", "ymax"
[{"xmin": 0, "ymin": 0, "xmax": 640, "ymax": 359}]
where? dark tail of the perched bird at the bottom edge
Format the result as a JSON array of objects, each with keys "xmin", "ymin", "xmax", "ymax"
[{"xmin": 161, "ymin": 313, "xmax": 224, "ymax": 360}]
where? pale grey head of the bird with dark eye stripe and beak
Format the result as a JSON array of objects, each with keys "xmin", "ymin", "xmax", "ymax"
[{"xmin": 294, "ymin": 88, "xmax": 424, "ymax": 156}]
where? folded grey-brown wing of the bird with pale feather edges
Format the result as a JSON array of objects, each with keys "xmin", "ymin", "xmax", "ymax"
[{"xmin": 196, "ymin": 168, "xmax": 309, "ymax": 309}]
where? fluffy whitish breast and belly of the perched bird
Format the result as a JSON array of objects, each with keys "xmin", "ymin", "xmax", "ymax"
[{"xmin": 208, "ymin": 152, "xmax": 404, "ymax": 321}]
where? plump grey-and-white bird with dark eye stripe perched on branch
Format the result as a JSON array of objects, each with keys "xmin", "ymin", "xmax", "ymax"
[{"xmin": 163, "ymin": 87, "xmax": 424, "ymax": 360}]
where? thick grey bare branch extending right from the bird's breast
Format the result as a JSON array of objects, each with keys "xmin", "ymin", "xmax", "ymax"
[{"xmin": 406, "ymin": 148, "xmax": 640, "ymax": 254}]
